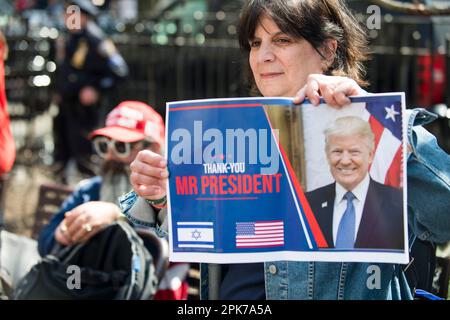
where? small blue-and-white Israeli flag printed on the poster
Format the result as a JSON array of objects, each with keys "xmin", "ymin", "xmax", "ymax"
[{"xmin": 177, "ymin": 222, "xmax": 214, "ymax": 249}]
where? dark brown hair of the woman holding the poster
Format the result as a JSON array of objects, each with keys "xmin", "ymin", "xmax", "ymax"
[{"xmin": 238, "ymin": 0, "xmax": 369, "ymax": 86}]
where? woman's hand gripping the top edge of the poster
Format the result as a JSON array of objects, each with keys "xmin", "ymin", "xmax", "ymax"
[{"xmin": 294, "ymin": 74, "xmax": 367, "ymax": 108}]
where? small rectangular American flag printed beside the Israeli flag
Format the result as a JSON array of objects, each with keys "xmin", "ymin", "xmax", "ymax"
[{"xmin": 236, "ymin": 220, "xmax": 284, "ymax": 248}]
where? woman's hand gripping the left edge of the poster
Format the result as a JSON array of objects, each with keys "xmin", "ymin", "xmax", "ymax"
[{"xmin": 130, "ymin": 150, "xmax": 169, "ymax": 200}]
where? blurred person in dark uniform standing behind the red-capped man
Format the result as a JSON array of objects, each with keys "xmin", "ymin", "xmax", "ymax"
[{"xmin": 53, "ymin": 0, "xmax": 128, "ymax": 182}]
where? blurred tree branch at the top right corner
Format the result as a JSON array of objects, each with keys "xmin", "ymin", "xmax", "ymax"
[{"xmin": 369, "ymin": 0, "xmax": 450, "ymax": 16}]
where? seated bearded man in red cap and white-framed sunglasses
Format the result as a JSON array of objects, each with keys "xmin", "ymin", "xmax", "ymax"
[{"xmin": 38, "ymin": 101, "xmax": 189, "ymax": 299}]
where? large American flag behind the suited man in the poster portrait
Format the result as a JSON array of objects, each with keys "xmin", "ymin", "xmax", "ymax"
[{"xmin": 363, "ymin": 101, "xmax": 403, "ymax": 187}]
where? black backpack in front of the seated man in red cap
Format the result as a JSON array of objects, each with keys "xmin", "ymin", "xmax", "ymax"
[{"xmin": 13, "ymin": 221, "xmax": 158, "ymax": 300}]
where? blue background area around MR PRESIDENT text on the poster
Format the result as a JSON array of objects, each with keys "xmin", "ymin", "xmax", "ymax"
[{"xmin": 168, "ymin": 100, "xmax": 317, "ymax": 253}]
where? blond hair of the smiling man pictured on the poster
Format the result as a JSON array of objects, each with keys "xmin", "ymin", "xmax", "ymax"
[{"xmin": 324, "ymin": 116, "xmax": 375, "ymax": 151}]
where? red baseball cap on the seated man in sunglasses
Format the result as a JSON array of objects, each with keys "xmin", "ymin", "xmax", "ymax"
[{"xmin": 89, "ymin": 101, "xmax": 165, "ymax": 147}]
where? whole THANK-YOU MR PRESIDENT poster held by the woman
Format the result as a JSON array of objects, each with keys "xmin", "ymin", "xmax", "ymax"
[{"xmin": 166, "ymin": 93, "xmax": 409, "ymax": 264}]
